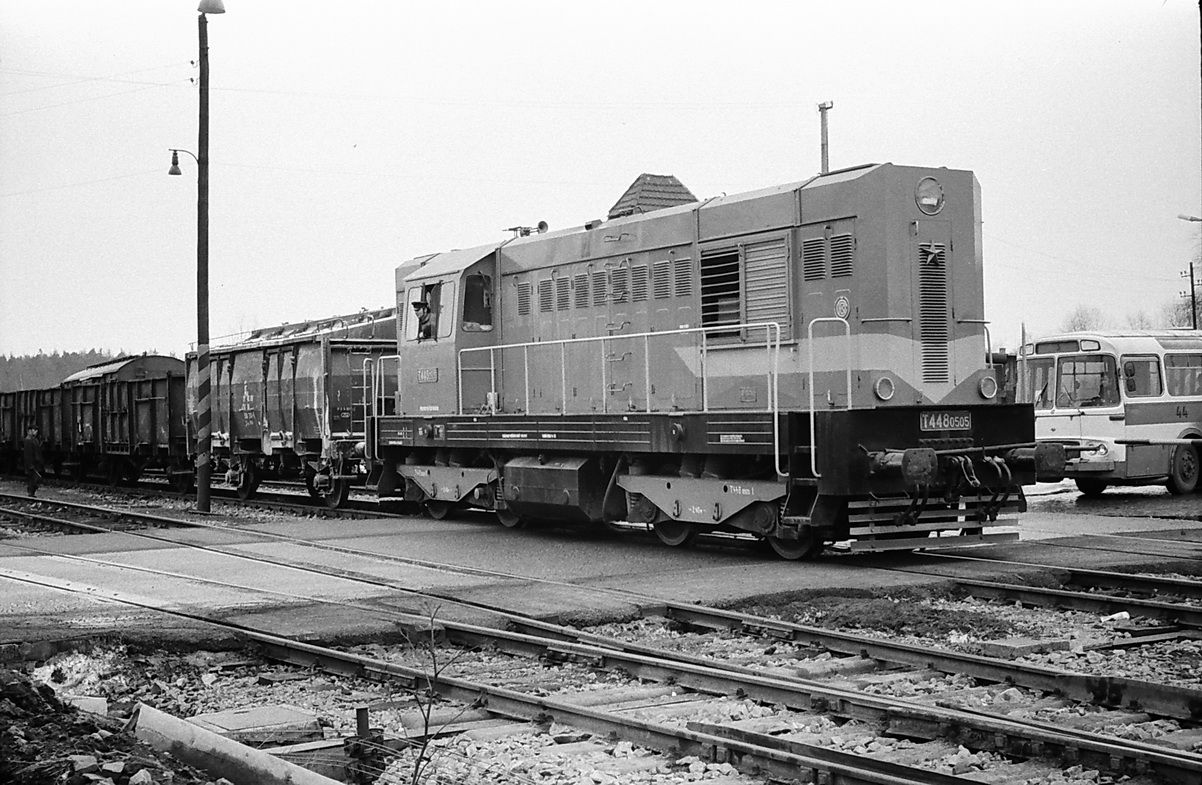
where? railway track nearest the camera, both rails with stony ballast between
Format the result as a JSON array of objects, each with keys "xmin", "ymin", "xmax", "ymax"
[{"xmin": 8, "ymin": 562, "xmax": 1202, "ymax": 783}]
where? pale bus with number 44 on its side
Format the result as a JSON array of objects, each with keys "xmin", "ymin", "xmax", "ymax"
[{"xmin": 1019, "ymin": 331, "xmax": 1202, "ymax": 496}]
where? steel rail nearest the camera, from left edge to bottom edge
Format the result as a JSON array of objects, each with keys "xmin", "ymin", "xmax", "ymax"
[{"xmin": 0, "ymin": 570, "xmax": 995, "ymax": 785}]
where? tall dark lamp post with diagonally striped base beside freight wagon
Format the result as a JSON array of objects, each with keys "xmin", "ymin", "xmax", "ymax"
[{"xmin": 167, "ymin": 0, "xmax": 225, "ymax": 512}]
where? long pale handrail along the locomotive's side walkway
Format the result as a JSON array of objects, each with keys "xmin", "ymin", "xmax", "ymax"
[{"xmin": 457, "ymin": 320, "xmax": 783, "ymax": 477}]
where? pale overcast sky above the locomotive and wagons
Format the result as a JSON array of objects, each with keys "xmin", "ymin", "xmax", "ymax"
[{"xmin": 0, "ymin": 0, "xmax": 1202, "ymax": 355}]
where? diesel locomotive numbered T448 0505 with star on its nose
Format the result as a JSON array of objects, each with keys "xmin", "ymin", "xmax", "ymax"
[{"xmin": 367, "ymin": 163, "xmax": 1064, "ymax": 559}]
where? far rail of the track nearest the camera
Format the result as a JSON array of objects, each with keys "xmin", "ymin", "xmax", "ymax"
[{"xmin": 9, "ymin": 543, "xmax": 1202, "ymax": 781}]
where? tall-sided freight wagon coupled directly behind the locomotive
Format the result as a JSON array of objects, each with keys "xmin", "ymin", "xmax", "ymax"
[{"xmin": 188, "ymin": 309, "xmax": 395, "ymax": 507}]
